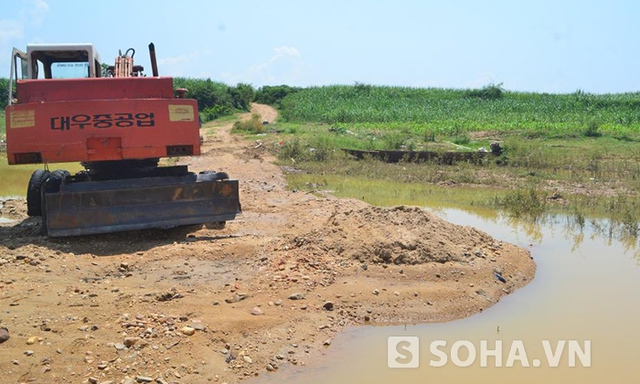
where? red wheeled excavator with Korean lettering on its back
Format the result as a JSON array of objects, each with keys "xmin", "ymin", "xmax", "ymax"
[{"xmin": 6, "ymin": 43, "xmax": 240, "ymax": 237}]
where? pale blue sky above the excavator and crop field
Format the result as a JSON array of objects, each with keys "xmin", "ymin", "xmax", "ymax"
[{"xmin": 0, "ymin": 0, "xmax": 640, "ymax": 93}]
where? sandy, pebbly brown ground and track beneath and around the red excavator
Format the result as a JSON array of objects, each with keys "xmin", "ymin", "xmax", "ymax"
[{"xmin": 0, "ymin": 105, "xmax": 535, "ymax": 384}]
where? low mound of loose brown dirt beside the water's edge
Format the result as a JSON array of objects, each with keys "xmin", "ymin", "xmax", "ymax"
[{"xmin": 282, "ymin": 201, "xmax": 499, "ymax": 264}]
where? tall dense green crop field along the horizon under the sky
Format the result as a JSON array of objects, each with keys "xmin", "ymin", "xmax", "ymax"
[{"xmin": 282, "ymin": 84, "xmax": 640, "ymax": 137}]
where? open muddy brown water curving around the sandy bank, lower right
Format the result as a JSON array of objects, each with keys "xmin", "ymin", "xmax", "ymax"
[{"xmin": 250, "ymin": 209, "xmax": 640, "ymax": 384}]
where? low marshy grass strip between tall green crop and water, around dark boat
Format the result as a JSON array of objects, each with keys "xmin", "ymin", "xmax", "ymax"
[{"xmin": 263, "ymin": 123, "xmax": 640, "ymax": 190}]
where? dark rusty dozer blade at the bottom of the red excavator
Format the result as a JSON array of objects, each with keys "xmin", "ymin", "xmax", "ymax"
[{"xmin": 43, "ymin": 175, "xmax": 240, "ymax": 237}]
